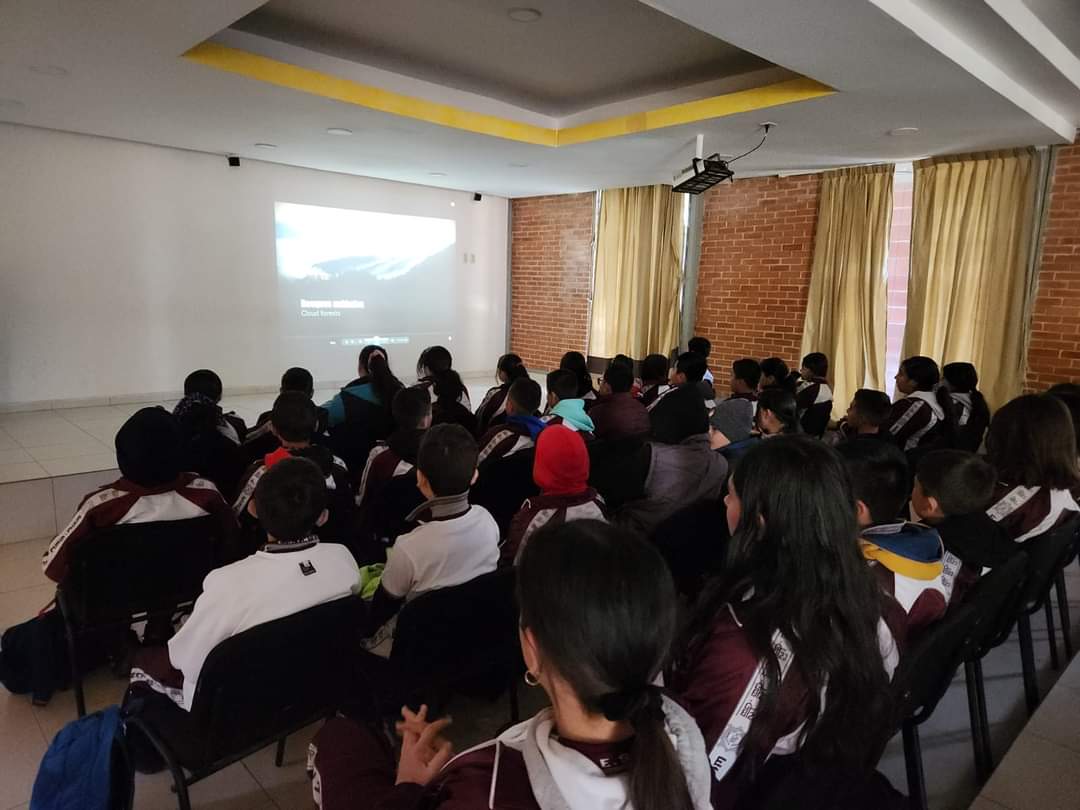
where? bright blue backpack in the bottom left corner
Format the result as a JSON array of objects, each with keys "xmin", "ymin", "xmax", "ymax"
[{"xmin": 30, "ymin": 706, "xmax": 135, "ymax": 810}]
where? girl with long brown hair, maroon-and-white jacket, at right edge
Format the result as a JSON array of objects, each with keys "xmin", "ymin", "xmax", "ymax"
[{"xmin": 986, "ymin": 394, "xmax": 1080, "ymax": 543}]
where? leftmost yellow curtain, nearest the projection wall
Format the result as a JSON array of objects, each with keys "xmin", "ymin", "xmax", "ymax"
[{"xmin": 589, "ymin": 186, "xmax": 686, "ymax": 360}]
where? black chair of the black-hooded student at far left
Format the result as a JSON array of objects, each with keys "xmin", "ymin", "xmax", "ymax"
[{"xmin": 56, "ymin": 516, "xmax": 224, "ymax": 717}]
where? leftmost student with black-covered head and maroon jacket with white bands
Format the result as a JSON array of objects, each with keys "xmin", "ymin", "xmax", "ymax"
[{"xmin": 41, "ymin": 407, "xmax": 237, "ymax": 583}]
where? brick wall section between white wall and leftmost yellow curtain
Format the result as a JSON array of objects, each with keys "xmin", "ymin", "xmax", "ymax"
[{"xmin": 510, "ymin": 192, "xmax": 596, "ymax": 369}]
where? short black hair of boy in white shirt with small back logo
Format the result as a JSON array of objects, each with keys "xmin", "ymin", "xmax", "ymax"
[{"xmin": 254, "ymin": 457, "xmax": 327, "ymax": 543}]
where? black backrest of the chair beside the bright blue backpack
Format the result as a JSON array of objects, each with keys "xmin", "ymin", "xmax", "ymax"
[{"xmin": 191, "ymin": 596, "xmax": 364, "ymax": 760}]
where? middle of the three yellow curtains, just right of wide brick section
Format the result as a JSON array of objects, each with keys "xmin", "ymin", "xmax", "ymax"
[{"xmin": 795, "ymin": 165, "xmax": 894, "ymax": 417}]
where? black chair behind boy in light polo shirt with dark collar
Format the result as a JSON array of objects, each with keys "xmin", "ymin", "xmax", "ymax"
[{"xmin": 382, "ymin": 568, "xmax": 525, "ymax": 723}]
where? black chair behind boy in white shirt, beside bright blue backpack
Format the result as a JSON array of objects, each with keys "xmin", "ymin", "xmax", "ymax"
[{"xmin": 125, "ymin": 596, "xmax": 364, "ymax": 810}]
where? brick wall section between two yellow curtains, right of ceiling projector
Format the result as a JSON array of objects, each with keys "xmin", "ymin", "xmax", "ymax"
[{"xmin": 694, "ymin": 175, "xmax": 821, "ymax": 375}]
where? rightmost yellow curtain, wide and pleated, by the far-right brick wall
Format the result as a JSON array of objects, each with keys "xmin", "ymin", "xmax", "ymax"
[{"xmin": 903, "ymin": 149, "xmax": 1039, "ymax": 408}]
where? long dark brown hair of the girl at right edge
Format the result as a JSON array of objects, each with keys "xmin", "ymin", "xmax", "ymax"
[{"xmin": 986, "ymin": 394, "xmax": 1080, "ymax": 489}]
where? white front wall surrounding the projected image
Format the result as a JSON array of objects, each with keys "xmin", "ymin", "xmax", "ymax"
[{"xmin": 0, "ymin": 124, "xmax": 508, "ymax": 403}]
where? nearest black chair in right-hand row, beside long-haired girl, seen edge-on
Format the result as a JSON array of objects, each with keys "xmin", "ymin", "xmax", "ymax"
[{"xmin": 892, "ymin": 604, "xmax": 978, "ymax": 810}]
